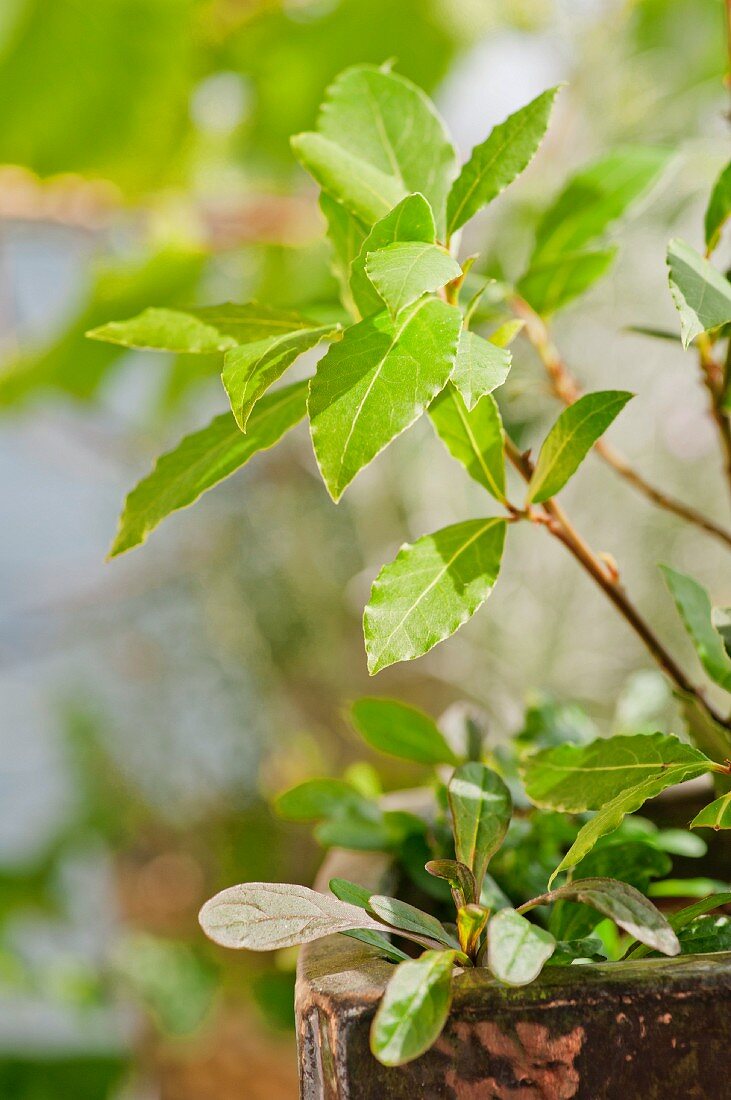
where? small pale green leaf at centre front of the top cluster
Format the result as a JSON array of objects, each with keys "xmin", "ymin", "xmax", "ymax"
[{"xmin": 365, "ymin": 241, "xmax": 462, "ymax": 314}]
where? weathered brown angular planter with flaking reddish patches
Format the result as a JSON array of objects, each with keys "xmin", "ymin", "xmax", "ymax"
[{"xmin": 296, "ymin": 851, "xmax": 731, "ymax": 1100}]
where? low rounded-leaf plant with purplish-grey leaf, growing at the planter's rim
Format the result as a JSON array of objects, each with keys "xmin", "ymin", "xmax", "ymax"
[{"xmin": 200, "ymin": 697, "xmax": 731, "ymax": 1066}]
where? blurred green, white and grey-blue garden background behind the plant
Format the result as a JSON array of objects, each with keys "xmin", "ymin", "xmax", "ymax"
[{"xmin": 0, "ymin": 0, "xmax": 731, "ymax": 1100}]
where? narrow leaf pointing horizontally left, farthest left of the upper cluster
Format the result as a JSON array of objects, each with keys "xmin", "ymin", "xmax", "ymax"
[{"xmin": 87, "ymin": 301, "xmax": 313, "ymax": 355}]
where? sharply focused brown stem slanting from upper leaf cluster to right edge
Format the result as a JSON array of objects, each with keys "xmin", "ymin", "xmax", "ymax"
[{"xmin": 506, "ymin": 436, "xmax": 731, "ymax": 756}]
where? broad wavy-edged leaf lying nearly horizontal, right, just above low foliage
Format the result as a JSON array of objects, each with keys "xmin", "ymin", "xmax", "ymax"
[{"xmin": 521, "ymin": 734, "xmax": 711, "ymax": 813}]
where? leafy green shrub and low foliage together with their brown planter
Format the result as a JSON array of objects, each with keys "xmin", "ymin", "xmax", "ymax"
[{"xmin": 90, "ymin": 66, "xmax": 731, "ymax": 1098}]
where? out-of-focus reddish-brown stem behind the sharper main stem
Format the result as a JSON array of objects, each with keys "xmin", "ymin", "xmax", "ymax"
[{"xmin": 512, "ymin": 297, "xmax": 731, "ymax": 547}]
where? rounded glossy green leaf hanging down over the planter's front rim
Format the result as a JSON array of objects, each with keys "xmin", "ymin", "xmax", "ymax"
[{"xmin": 370, "ymin": 952, "xmax": 454, "ymax": 1066}]
